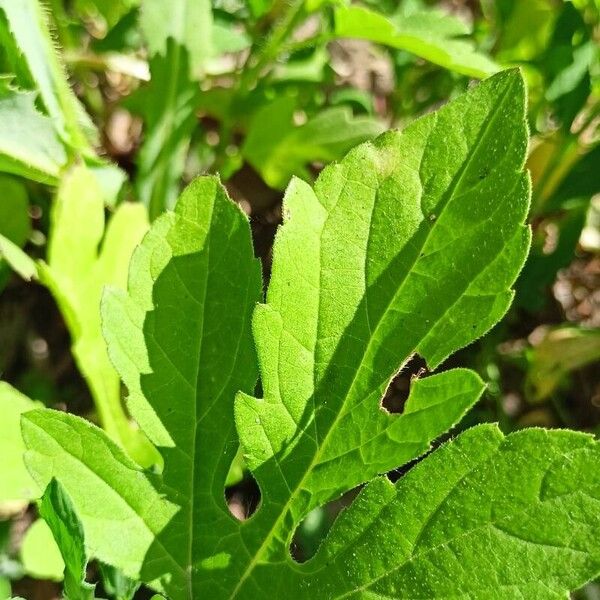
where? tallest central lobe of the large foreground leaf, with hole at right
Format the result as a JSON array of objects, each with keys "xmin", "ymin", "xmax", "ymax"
[{"xmin": 228, "ymin": 71, "xmax": 529, "ymax": 597}]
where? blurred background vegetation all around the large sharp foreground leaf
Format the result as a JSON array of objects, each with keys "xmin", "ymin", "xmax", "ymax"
[{"xmin": 0, "ymin": 0, "xmax": 600, "ymax": 600}]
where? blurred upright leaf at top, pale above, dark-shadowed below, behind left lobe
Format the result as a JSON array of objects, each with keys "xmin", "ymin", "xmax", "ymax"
[{"xmin": 137, "ymin": 0, "xmax": 213, "ymax": 220}]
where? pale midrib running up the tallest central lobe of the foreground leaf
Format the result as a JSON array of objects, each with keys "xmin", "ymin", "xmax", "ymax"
[{"xmin": 229, "ymin": 81, "xmax": 512, "ymax": 600}]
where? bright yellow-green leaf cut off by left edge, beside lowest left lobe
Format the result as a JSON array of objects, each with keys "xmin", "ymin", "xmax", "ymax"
[{"xmin": 0, "ymin": 381, "xmax": 38, "ymax": 506}]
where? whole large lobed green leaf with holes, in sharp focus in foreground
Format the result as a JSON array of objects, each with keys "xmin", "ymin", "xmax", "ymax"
[{"xmin": 23, "ymin": 71, "xmax": 600, "ymax": 600}]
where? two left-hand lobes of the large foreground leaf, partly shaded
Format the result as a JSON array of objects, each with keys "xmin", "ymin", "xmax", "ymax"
[{"xmin": 23, "ymin": 177, "xmax": 261, "ymax": 597}]
